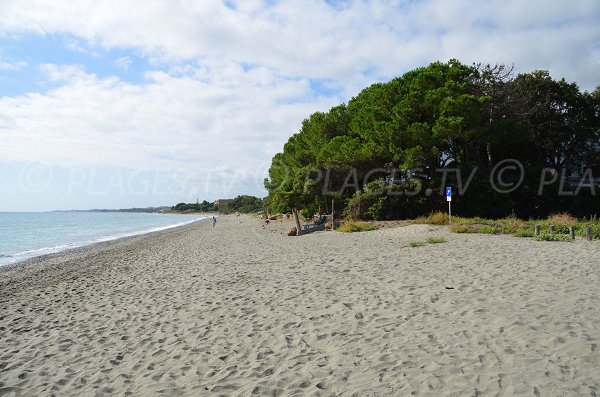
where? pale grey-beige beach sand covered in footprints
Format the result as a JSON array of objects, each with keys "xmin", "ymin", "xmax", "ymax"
[{"xmin": 0, "ymin": 216, "xmax": 600, "ymax": 396}]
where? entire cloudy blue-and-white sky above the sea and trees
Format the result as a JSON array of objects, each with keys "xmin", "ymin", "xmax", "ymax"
[{"xmin": 0, "ymin": 0, "xmax": 600, "ymax": 211}]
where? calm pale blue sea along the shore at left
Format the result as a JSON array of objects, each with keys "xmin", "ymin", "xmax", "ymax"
[{"xmin": 0, "ymin": 211, "xmax": 206, "ymax": 266}]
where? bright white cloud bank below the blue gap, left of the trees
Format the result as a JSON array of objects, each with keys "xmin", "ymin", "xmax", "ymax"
[{"xmin": 0, "ymin": 63, "xmax": 334, "ymax": 176}]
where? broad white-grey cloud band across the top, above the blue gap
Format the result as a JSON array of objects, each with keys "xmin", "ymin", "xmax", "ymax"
[{"xmin": 0, "ymin": 0, "xmax": 600, "ymax": 84}]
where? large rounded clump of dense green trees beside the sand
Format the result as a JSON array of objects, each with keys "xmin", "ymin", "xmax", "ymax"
[{"xmin": 265, "ymin": 60, "xmax": 600, "ymax": 219}]
